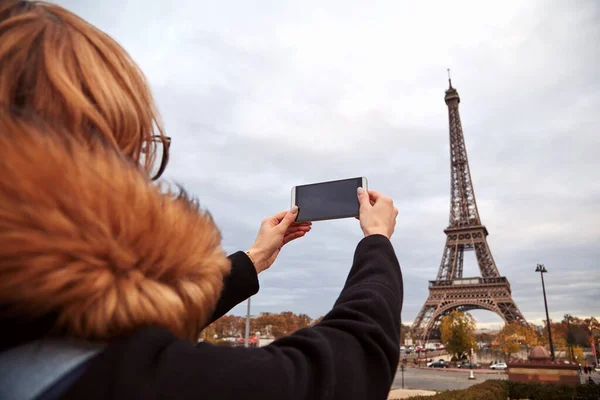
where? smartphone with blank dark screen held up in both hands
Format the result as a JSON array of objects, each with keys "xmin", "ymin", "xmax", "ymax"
[{"xmin": 292, "ymin": 177, "xmax": 368, "ymax": 222}]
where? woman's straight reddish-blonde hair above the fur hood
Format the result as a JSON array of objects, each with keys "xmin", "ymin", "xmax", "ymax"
[{"xmin": 0, "ymin": 0, "xmax": 168, "ymax": 177}]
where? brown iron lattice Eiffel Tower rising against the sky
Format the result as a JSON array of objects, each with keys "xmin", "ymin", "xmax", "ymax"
[{"xmin": 412, "ymin": 71, "xmax": 525, "ymax": 343}]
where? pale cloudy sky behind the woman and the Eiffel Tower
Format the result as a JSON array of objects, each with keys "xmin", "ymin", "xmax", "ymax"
[{"xmin": 58, "ymin": 0, "xmax": 600, "ymax": 327}]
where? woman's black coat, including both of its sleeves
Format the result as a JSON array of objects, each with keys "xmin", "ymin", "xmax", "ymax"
[{"xmin": 57, "ymin": 235, "xmax": 403, "ymax": 400}]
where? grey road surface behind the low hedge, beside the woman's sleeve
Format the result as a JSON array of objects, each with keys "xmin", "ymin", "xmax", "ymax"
[{"xmin": 392, "ymin": 367, "xmax": 506, "ymax": 390}]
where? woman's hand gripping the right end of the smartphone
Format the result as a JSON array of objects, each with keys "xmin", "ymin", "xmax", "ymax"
[{"xmin": 357, "ymin": 187, "xmax": 398, "ymax": 239}]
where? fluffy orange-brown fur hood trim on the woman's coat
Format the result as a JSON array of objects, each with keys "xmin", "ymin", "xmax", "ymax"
[{"xmin": 0, "ymin": 115, "xmax": 230, "ymax": 340}]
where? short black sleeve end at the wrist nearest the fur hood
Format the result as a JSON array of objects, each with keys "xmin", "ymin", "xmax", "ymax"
[{"xmin": 209, "ymin": 251, "xmax": 259, "ymax": 324}]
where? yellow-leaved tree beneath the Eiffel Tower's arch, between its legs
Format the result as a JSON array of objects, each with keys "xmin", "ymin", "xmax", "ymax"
[{"xmin": 440, "ymin": 310, "xmax": 477, "ymax": 358}]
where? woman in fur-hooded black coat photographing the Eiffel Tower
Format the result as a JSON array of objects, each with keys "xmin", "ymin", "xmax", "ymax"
[{"xmin": 0, "ymin": 1, "xmax": 402, "ymax": 399}]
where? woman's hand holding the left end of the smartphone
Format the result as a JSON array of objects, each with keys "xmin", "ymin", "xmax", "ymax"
[{"xmin": 246, "ymin": 206, "xmax": 312, "ymax": 273}]
